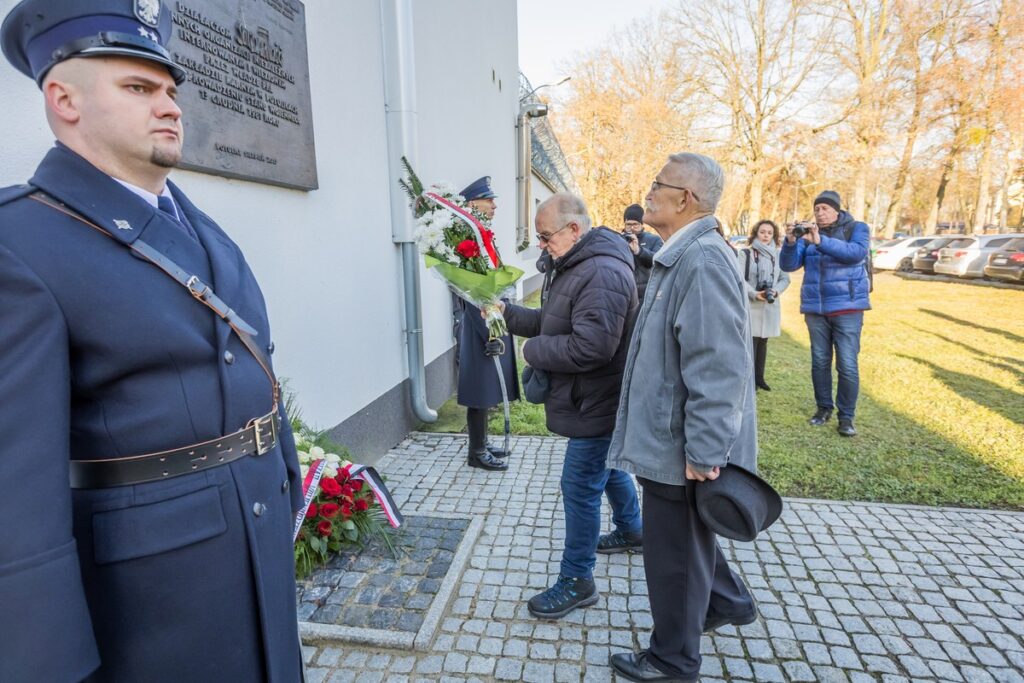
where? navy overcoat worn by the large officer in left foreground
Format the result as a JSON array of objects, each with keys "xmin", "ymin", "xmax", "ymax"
[{"xmin": 0, "ymin": 144, "xmax": 301, "ymax": 683}]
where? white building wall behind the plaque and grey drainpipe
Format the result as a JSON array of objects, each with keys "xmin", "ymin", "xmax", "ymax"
[{"xmin": 0, "ymin": 0, "xmax": 518, "ymax": 427}]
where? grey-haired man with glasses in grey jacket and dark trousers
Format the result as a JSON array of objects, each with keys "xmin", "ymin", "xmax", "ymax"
[{"xmin": 608, "ymin": 154, "xmax": 757, "ymax": 681}]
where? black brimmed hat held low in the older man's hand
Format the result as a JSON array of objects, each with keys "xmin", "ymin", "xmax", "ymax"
[{"xmin": 692, "ymin": 465, "xmax": 782, "ymax": 541}]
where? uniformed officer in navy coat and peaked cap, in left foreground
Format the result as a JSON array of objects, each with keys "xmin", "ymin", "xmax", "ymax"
[{"xmin": 0, "ymin": 0, "xmax": 301, "ymax": 683}]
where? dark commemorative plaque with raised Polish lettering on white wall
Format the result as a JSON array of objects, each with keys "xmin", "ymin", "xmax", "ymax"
[{"xmin": 168, "ymin": 0, "xmax": 317, "ymax": 189}]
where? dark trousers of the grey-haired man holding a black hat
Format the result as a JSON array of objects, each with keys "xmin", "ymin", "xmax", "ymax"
[{"xmin": 640, "ymin": 479, "xmax": 754, "ymax": 679}]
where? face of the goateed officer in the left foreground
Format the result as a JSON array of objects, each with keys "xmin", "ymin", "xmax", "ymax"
[{"xmin": 73, "ymin": 57, "xmax": 184, "ymax": 174}]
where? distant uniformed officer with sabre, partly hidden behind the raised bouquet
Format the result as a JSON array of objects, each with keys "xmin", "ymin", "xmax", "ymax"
[{"xmin": 457, "ymin": 176, "xmax": 519, "ymax": 470}]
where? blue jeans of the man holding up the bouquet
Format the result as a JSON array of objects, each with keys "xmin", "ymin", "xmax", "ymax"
[{"xmin": 561, "ymin": 434, "xmax": 642, "ymax": 579}]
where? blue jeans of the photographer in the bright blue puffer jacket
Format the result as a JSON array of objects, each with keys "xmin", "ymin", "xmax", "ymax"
[{"xmin": 804, "ymin": 310, "xmax": 864, "ymax": 420}]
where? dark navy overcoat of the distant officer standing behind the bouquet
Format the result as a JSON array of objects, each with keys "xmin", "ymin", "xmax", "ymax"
[{"xmin": 457, "ymin": 299, "xmax": 519, "ymax": 408}]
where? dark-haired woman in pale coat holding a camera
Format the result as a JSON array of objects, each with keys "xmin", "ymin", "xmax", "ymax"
[{"xmin": 739, "ymin": 220, "xmax": 790, "ymax": 391}]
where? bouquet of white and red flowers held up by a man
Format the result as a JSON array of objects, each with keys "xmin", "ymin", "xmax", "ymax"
[{"xmin": 398, "ymin": 157, "xmax": 523, "ymax": 339}]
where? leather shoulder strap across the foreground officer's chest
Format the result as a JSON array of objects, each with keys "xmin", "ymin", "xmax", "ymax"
[{"xmin": 29, "ymin": 190, "xmax": 281, "ymax": 405}]
